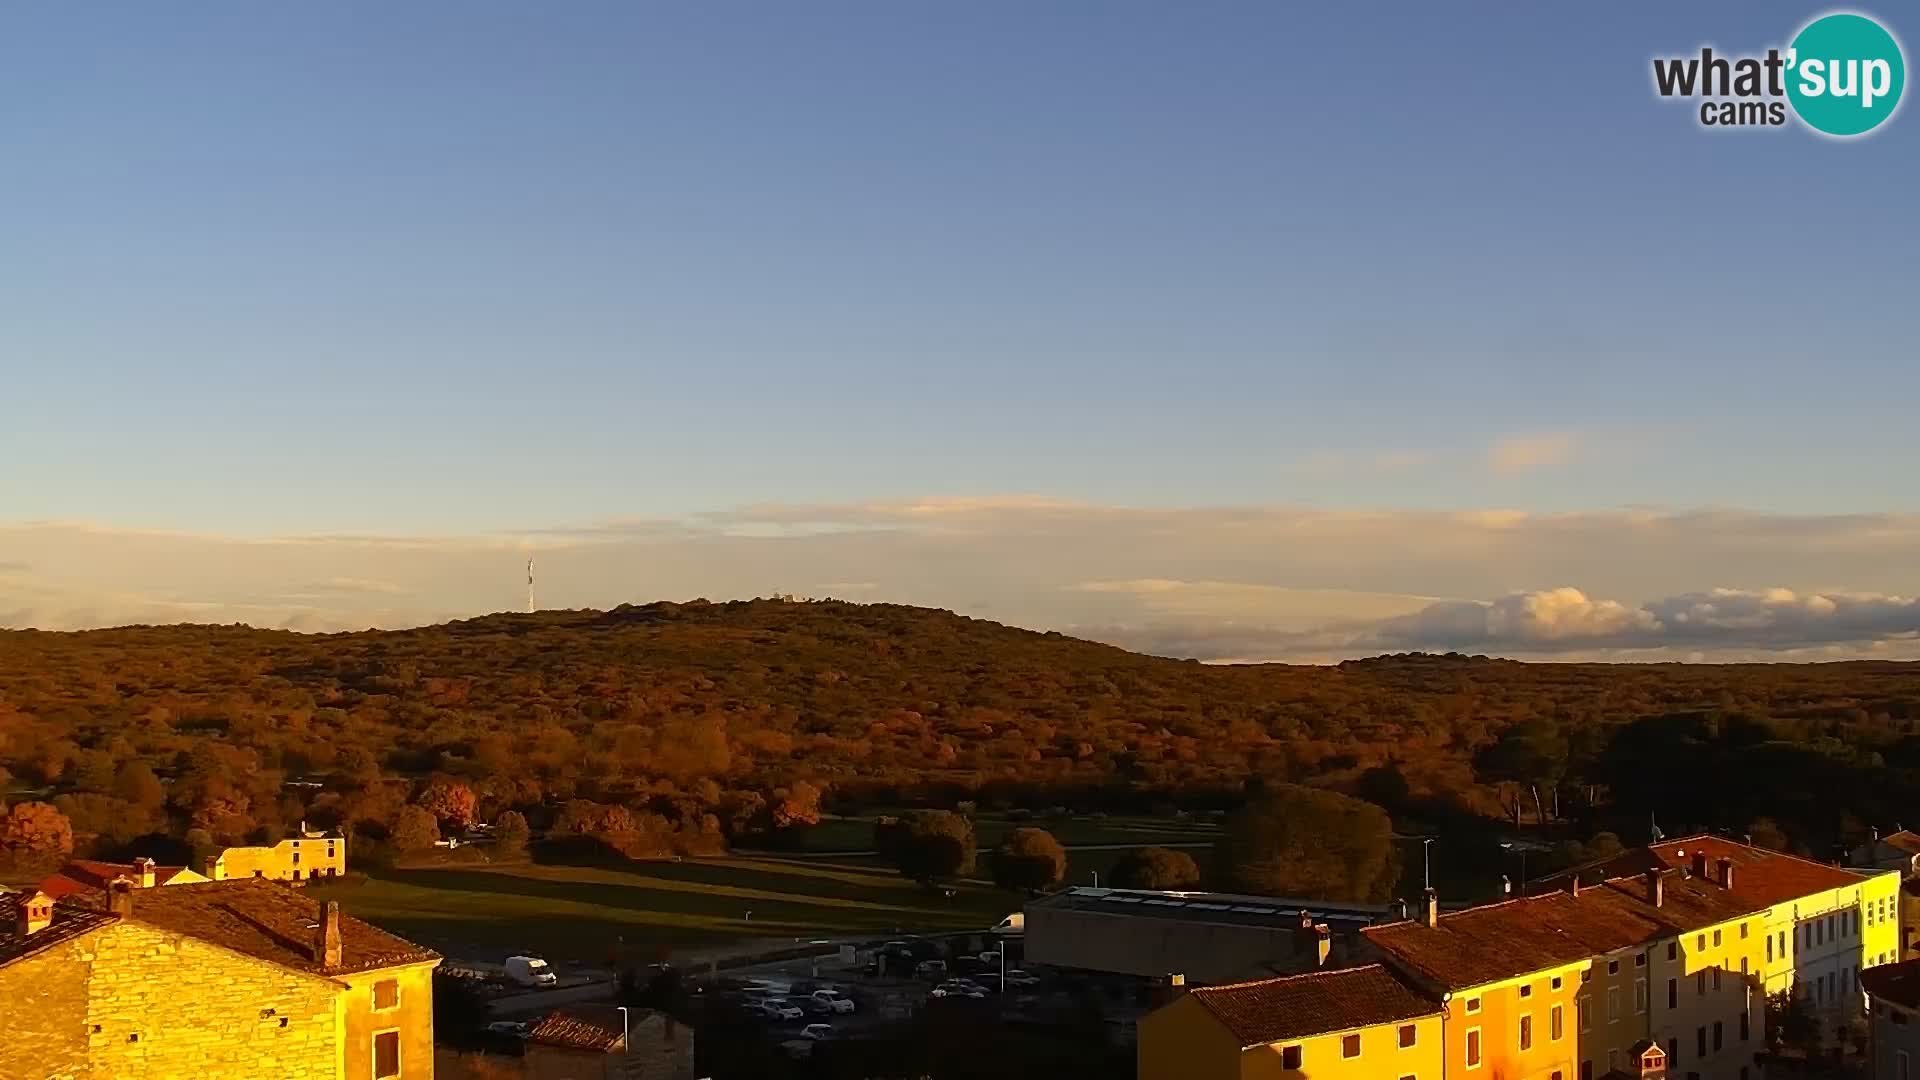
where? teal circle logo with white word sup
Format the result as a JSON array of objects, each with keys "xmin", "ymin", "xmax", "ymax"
[{"xmin": 1788, "ymin": 13, "xmax": 1907, "ymax": 136}]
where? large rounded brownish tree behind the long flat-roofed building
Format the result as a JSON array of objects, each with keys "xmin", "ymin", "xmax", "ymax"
[{"xmin": 1213, "ymin": 784, "xmax": 1400, "ymax": 903}]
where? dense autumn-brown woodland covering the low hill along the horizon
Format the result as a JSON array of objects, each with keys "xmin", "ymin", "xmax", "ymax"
[{"xmin": 0, "ymin": 600, "xmax": 1920, "ymax": 883}]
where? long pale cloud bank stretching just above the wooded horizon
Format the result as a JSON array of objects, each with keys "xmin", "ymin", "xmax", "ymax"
[{"xmin": 0, "ymin": 499, "xmax": 1920, "ymax": 663}]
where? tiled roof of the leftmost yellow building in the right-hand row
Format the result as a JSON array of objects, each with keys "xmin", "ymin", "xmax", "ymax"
[{"xmin": 1190, "ymin": 965, "xmax": 1444, "ymax": 1045}]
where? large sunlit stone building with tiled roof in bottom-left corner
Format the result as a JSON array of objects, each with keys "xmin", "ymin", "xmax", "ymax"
[{"xmin": 0, "ymin": 868, "xmax": 440, "ymax": 1080}]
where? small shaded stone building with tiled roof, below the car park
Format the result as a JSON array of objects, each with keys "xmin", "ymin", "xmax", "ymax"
[{"xmin": 524, "ymin": 1005, "xmax": 693, "ymax": 1080}]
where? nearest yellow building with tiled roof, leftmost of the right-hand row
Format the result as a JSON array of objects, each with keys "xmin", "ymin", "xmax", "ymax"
[{"xmin": 1137, "ymin": 965, "xmax": 1444, "ymax": 1080}]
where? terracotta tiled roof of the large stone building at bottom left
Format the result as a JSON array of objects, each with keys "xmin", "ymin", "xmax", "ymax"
[{"xmin": 72, "ymin": 878, "xmax": 440, "ymax": 974}]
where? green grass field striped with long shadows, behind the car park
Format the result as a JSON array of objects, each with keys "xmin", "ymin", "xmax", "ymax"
[{"xmin": 313, "ymin": 857, "xmax": 1020, "ymax": 963}]
